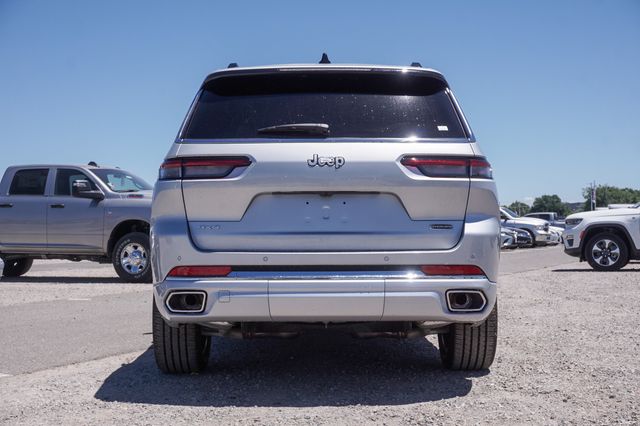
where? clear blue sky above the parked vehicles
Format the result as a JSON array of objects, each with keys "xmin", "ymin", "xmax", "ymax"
[{"xmin": 0, "ymin": 0, "xmax": 640, "ymax": 204}]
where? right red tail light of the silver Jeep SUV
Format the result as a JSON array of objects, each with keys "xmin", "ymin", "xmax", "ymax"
[{"xmin": 400, "ymin": 156, "xmax": 493, "ymax": 179}]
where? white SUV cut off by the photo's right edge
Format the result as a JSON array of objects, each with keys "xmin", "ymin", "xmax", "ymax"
[{"xmin": 562, "ymin": 204, "xmax": 640, "ymax": 271}]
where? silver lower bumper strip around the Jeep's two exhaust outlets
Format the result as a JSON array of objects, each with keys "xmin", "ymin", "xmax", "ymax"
[{"xmin": 154, "ymin": 277, "xmax": 496, "ymax": 324}]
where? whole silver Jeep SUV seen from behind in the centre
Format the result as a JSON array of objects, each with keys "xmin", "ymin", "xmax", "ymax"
[{"xmin": 151, "ymin": 60, "xmax": 500, "ymax": 373}]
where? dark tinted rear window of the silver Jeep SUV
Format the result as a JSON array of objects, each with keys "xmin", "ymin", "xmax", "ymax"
[{"xmin": 181, "ymin": 71, "xmax": 466, "ymax": 139}]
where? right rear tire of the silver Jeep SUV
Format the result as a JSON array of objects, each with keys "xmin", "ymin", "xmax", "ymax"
[{"xmin": 438, "ymin": 303, "xmax": 498, "ymax": 370}]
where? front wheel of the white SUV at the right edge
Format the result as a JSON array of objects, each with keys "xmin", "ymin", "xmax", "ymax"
[{"xmin": 584, "ymin": 232, "xmax": 629, "ymax": 271}]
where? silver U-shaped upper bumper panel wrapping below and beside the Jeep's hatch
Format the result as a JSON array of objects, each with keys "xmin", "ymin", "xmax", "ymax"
[{"xmin": 151, "ymin": 180, "xmax": 500, "ymax": 283}]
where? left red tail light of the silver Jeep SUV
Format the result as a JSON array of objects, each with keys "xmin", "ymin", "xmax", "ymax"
[{"xmin": 159, "ymin": 157, "xmax": 251, "ymax": 180}]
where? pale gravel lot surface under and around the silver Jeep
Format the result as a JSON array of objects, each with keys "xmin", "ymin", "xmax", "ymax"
[{"xmin": 0, "ymin": 251, "xmax": 640, "ymax": 425}]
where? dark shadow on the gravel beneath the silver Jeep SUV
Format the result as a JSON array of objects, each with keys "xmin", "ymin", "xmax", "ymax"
[{"xmin": 95, "ymin": 331, "xmax": 488, "ymax": 407}]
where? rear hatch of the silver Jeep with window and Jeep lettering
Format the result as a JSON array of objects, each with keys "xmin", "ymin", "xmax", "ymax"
[{"xmin": 172, "ymin": 69, "xmax": 474, "ymax": 252}]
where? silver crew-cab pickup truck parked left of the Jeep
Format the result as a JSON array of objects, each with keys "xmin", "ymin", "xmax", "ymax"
[{"xmin": 0, "ymin": 162, "xmax": 152, "ymax": 282}]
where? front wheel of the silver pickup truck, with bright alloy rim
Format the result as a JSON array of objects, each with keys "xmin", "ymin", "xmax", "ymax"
[{"xmin": 111, "ymin": 232, "xmax": 152, "ymax": 283}]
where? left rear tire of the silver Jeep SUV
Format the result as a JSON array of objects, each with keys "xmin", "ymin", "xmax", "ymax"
[{"xmin": 153, "ymin": 299, "xmax": 211, "ymax": 374}]
